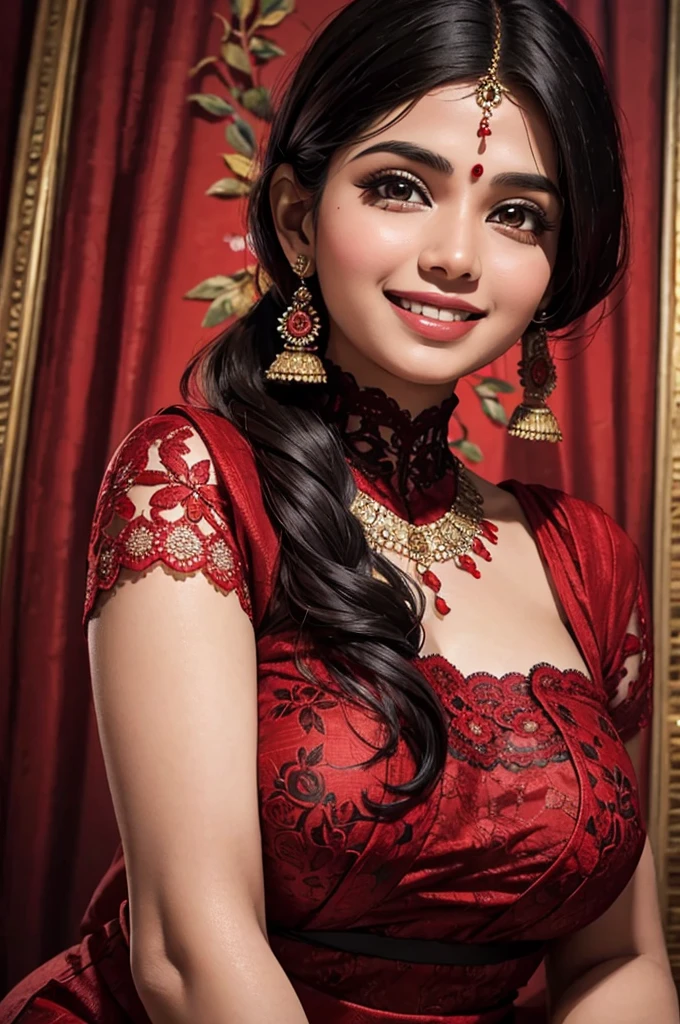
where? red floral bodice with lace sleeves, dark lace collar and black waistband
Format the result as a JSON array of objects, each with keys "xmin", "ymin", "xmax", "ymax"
[{"xmin": 83, "ymin": 375, "xmax": 652, "ymax": 1024}]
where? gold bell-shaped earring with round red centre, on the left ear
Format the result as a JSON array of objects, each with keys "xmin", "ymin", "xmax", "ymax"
[{"xmin": 264, "ymin": 253, "xmax": 327, "ymax": 384}]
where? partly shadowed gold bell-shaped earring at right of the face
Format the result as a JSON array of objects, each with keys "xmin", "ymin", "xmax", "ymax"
[{"xmin": 508, "ymin": 314, "xmax": 562, "ymax": 441}]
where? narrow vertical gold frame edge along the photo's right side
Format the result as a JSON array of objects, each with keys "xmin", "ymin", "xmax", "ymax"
[{"xmin": 649, "ymin": 0, "xmax": 680, "ymax": 981}]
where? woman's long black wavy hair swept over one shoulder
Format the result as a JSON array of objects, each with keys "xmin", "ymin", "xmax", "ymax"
[{"xmin": 182, "ymin": 0, "xmax": 628, "ymax": 818}]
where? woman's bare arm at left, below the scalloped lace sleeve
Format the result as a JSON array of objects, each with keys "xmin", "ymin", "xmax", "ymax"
[{"xmin": 89, "ymin": 524, "xmax": 306, "ymax": 1024}]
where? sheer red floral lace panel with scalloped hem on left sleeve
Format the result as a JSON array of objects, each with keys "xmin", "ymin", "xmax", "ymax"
[{"xmin": 83, "ymin": 414, "xmax": 252, "ymax": 624}]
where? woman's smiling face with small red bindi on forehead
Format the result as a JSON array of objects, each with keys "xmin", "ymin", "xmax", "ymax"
[{"xmin": 293, "ymin": 83, "xmax": 561, "ymax": 397}]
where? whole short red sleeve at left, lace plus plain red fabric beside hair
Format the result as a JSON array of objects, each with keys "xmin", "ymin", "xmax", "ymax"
[{"xmin": 84, "ymin": 406, "xmax": 266, "ymax": 622}]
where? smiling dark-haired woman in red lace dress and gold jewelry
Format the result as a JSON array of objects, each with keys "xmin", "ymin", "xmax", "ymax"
[{"xmin": 0, "ymin": 0, "xmax": 679, "ymax": 1024}]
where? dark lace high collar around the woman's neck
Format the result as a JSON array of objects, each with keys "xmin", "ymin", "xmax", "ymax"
[{"xmin": 318, "ymin": 358, "xmax": 459, "ymax": 521}]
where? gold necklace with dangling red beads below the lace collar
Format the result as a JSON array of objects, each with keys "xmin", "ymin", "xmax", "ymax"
[{"xmin": 349, "ymin": 456, "xmax": 498, "ymax": 615}]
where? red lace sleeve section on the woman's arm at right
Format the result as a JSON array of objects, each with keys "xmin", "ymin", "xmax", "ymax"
[{"xmin": 606, "ymin": 569, "xmax": 653, "ymax": 742}]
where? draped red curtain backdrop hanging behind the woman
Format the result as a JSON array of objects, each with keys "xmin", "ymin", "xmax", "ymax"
[{"xmin": 0, "ymin": 0, "xmax": 666, "ymax": 999}]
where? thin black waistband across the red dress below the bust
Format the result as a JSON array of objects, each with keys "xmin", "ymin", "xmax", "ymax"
[{"xmin": 267, "ymin": 925, "xmax": 546, "ymax": 967}]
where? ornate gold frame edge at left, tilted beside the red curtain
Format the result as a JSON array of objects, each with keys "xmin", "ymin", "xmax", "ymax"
[{"xmin": 0, "ymin": 0, "xmax": 86, "ymax": 581}]
